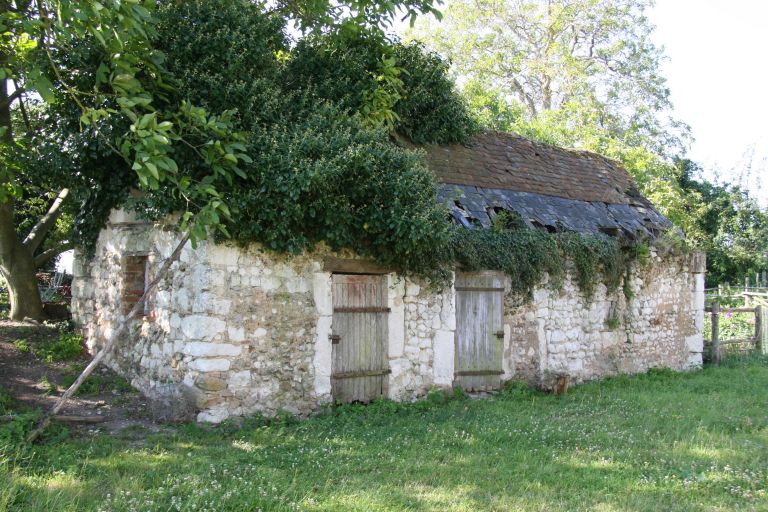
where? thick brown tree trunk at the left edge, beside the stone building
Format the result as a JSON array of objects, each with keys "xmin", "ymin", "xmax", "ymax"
[{"xmin": 0, "ymin": 201, "xmax": 45, "ymax": 320}]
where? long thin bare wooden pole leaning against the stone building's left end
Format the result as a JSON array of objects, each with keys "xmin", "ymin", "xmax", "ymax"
[{"xmin": 27, "ymin": 232, "xmax": 189, "ymax": 443}]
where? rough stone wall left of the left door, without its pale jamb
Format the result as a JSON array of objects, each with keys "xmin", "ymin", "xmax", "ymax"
[{"xmin": 73, "ymin": 214, "xmax": 330, "ymax": 421}]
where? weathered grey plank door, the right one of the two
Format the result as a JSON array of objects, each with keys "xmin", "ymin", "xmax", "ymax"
[{"xmin": 454, "ymin": 272, "xmax": 504, "ymax": 391}]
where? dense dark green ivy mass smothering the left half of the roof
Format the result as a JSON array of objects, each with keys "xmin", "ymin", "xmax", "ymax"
[{"xmin": 57, "ymin": 0, "xmax": 477, "ymax": 275}]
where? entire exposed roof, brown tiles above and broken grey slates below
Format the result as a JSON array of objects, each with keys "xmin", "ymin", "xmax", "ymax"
[{"xmin": 414, "ymin": 133, "xmax": 672, "ymax": 240}]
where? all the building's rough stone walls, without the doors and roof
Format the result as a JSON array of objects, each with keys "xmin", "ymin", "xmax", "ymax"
[{"xmin": 72, "ymin": 212, "xmax": 704, "ymax": 422}]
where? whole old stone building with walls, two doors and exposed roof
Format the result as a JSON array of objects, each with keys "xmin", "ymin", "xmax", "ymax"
[{"xmin": 72, "ymin": 134, "xmax": 704, "ymax": 422}]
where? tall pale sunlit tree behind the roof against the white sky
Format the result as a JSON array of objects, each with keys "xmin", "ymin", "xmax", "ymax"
[{"xmin": 414, "ymin": 0, "xmax": 685, "ymax": 154}]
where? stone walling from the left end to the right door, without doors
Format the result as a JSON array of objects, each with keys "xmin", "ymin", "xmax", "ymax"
[{"xmin": 72, "ymin": 211, "xmax": 455, "ymax": 422}]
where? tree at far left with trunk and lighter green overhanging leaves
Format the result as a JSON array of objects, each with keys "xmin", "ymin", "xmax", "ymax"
[{"xmin": 0, "ymin": 0, "xmax": 444, "ymax": 319}]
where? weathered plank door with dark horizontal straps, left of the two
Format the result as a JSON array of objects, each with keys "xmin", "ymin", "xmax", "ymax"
[{"xmin": 331, "ymin": 274, "xmax": 389, "ymax": 402}]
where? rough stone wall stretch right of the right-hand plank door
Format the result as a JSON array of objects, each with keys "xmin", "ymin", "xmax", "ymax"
[{"xmin": 505, "ymin": 252, "xmax": 704, "ymax": 387}]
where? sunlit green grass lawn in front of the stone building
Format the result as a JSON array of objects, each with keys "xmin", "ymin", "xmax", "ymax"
[{"xmin": 0, "ymin": 359, "xmax": 768, "ymax": 511}]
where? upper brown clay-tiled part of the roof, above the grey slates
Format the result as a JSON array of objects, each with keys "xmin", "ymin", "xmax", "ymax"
[{"xmin": 421, "ymin": 133, "xmax": 649, "ymax": 205}]
